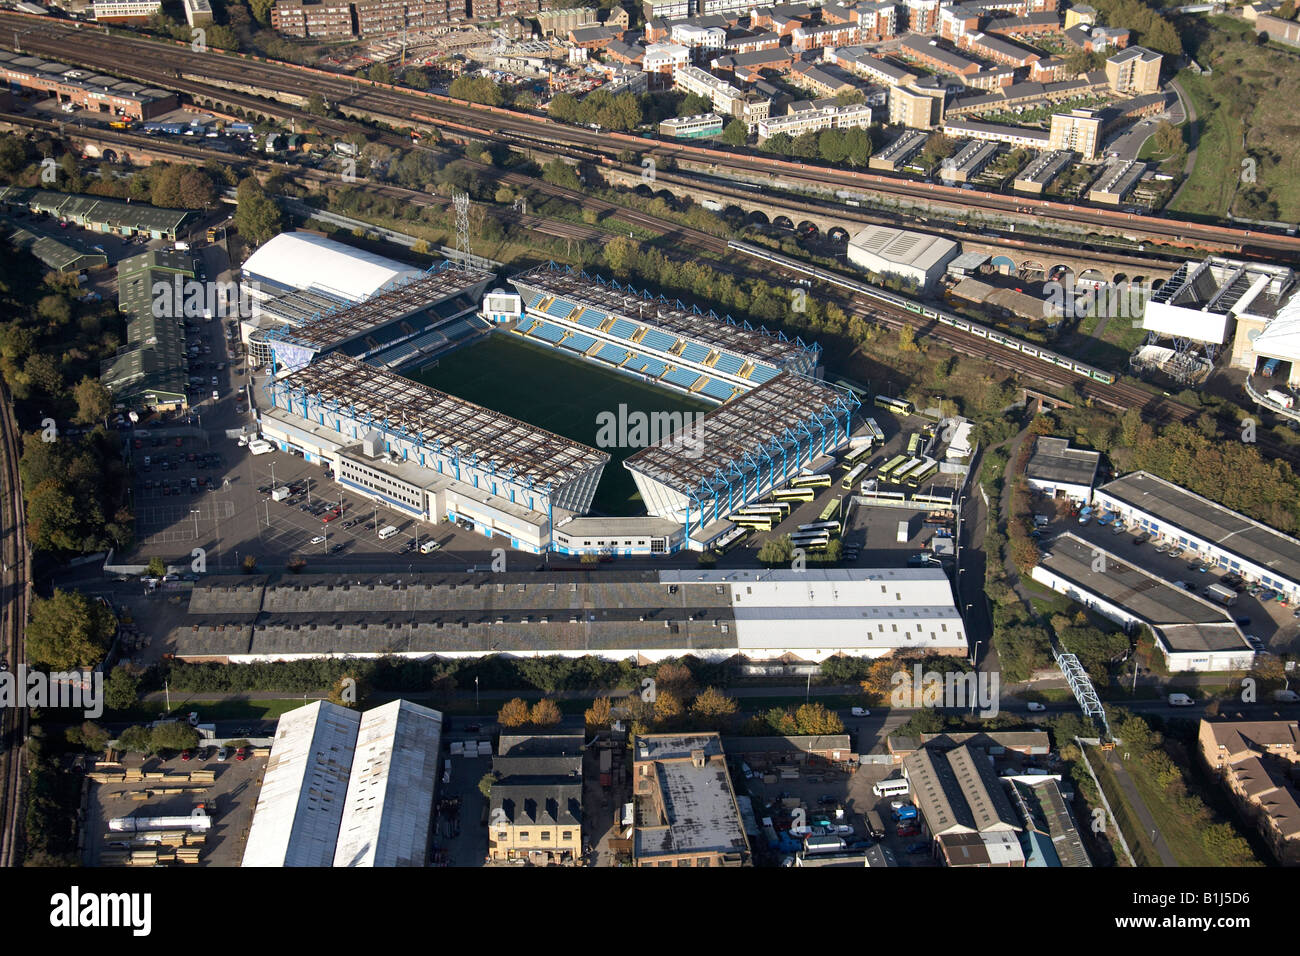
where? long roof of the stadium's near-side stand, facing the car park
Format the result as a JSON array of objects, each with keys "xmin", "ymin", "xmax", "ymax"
[{"xmin": 276, "ymin": 352, "xmax": 610, "ymax": 486}]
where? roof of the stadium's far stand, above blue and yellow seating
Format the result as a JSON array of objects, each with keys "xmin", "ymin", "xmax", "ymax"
[{"xmin": 510, "ymin": 263, "xmax": 820, "ymax": 368}]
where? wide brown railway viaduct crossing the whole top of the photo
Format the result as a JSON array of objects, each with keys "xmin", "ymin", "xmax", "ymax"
[{"xmin": 10, "ymin": 13, "xmax": 1300, "ymax": 265}]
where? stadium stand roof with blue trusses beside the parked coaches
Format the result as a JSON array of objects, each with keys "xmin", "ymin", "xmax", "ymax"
[{"xmin": 624, "ymin": 372, "xmax": 855, "ymax": 497}]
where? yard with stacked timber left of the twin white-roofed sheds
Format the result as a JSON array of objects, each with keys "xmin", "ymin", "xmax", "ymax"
[{"xmin": 83, "ymin": 747, "xmax": 267, "ymax": 866}]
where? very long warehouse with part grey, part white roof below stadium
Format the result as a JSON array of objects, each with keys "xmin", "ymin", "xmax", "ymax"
[{"xmin": 168, "ymin": 567, "xmax": 969, "ymax": 663}]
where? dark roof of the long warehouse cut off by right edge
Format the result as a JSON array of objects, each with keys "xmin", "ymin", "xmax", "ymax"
[{"xmin": 1097, "ymin": 471, "xmax": 1300, "ymax": 587}]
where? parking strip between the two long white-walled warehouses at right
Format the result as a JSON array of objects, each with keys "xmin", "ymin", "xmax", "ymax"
[{"xmin": 1032, "ymin": 494, "xmax": 1300, "ymax": 654}]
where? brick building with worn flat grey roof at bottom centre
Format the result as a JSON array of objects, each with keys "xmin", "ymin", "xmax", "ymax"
[{"xmin": 632, "ymin": 734, "xmax": 753, "ymax": 869}]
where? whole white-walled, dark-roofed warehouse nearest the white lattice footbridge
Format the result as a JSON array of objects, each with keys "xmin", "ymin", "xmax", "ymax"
[{"xmin": 1032, "ymin": 532, "xmax": 1255, "ymax": 671}]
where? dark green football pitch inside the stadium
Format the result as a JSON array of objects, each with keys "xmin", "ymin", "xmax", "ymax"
[{"xmin": 415, "ymin": 332, "xmax": 714, "ymax": 515}]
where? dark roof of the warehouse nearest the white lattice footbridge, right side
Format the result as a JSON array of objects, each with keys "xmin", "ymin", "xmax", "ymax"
[{"xmin": 1039, "ymin": 532, "xmax": 1249, "ymax": 653}]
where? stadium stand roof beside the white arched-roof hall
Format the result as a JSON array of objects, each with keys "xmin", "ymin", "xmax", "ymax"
[{"xmin": 263, "ymin": 257, "xmax": 493, "ymax": 349}]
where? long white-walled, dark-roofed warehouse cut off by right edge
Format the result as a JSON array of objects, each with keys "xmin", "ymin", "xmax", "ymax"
[{"xmin": 1093, "ymin": 471, "xmax": 1300, "ymax": 602}]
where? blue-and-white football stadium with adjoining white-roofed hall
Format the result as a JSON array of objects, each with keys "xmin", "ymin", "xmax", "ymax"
[{"xmin": 244, "ymin": 233, "xmax": 859, "ymax": 555}]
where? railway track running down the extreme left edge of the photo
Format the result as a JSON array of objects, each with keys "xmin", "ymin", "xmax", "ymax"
[{"xmin": 0, "ymin": 386, "xmax": 31, "ymax": 866}]
